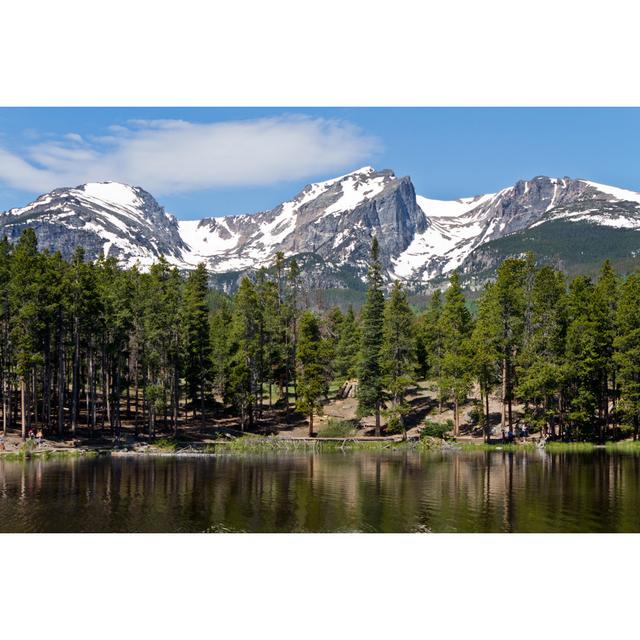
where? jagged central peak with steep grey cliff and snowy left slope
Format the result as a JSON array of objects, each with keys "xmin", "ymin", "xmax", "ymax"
[{"xmin": 180, "ymin": 167, "xmax": 427, "ymax": 272}]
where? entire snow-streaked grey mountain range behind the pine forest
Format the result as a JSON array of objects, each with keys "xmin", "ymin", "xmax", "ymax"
[{"xmin": 0, "ymin": 167, "xmax": 640, "ymax": 290}]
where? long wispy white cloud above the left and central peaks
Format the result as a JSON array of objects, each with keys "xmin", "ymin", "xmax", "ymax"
[{"xmin": 0, "ymin": 116, "xmax": 378, "ymax": 194}]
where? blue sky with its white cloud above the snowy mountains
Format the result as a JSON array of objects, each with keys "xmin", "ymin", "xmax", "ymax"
[{"xmin": 0, "ymin": 107, "xmax": 640, "ymax": 219}]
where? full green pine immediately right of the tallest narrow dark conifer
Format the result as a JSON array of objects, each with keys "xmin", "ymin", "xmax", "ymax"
[{"xmin": 381, "ymin": 281, "xmax": 417, "ymax": 438}]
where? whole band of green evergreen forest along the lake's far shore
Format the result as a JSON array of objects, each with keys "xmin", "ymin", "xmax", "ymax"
[{"xmin": 0, "ymin": 229, "xmax": 640, "ymax": 442}]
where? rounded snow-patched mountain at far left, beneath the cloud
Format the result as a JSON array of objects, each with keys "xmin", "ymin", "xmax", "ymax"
[{"xmin": 0, "ymin": 182, "xmax": 187, "ymax": 265}]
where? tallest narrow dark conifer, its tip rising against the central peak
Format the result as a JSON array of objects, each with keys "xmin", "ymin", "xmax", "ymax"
[{"xmin": 358, "ymin": 237, "xmax": 384, "ymax": 436}]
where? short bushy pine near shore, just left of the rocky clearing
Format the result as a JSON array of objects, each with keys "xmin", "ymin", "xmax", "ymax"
[{"xmin": 296, "ymin": 311, "xmax": 329, "ymax": 437}]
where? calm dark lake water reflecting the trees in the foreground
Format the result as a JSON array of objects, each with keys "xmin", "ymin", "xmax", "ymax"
[{"xmin": 0, "ymin": 451, "xmax": 640, "ymax": 532}]
